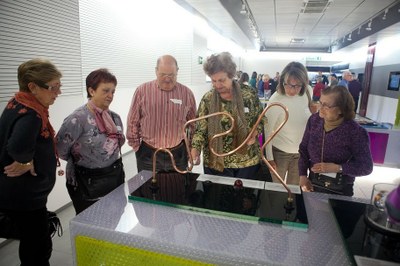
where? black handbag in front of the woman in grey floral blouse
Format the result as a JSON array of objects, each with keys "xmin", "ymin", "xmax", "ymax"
[{"xmin": 75, "ymin": 158, "xmax": 125, "ymax": 199}]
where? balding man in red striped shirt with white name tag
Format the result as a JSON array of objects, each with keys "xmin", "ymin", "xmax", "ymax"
[{"xmin": 126, "ymin": 55, "xmax": 196, "ymax": 172}]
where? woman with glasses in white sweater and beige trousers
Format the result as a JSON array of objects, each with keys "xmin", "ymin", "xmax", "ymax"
[{"xmin": 266, "ymin": 62, "xmax": 314, "ymax": 185}]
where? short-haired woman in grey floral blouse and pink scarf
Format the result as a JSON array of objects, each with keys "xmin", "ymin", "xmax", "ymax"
[{"xmin": 56, "ymin": 68, "xmax": 125, "ymax": 214}]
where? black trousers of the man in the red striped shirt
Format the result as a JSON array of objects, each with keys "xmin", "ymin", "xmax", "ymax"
[{"xmin": 136, "ymin": 141, "xmax": 188, "ymax": 173}]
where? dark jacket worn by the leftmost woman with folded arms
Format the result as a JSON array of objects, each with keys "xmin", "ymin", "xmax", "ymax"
[{"xmin": 0, "ymin": 100, "xmax": 57, "ymax": 211}]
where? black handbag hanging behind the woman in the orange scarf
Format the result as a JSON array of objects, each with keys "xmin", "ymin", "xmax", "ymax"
[{"xmin": 0, "ymin": 211, "xmax": 63, "ymax": 239}]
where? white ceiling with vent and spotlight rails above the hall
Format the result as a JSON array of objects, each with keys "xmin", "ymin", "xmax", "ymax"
[{"xmin": 176, "ymin": 0, "xmax": 400, "ymax": 51}]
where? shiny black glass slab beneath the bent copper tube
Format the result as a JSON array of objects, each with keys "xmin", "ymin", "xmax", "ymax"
[{"xmin": 129, "ymin": 173, "xmax": 308, "ymax": 230}]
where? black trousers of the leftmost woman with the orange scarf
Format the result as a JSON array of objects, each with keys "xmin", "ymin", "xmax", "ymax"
[{"xmin": 7, "ymin": 208, "xmax": 53, "ymax": 266}]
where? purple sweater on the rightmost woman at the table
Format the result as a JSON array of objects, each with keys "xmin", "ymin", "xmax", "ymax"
[{"xmin": 299, "ymin": 113, "xmax": 373, "ymax": 183}]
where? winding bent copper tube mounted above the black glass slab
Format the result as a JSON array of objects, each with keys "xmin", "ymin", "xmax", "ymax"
[{"xmin": 152, "ymin": 103, "xmax": 293, "ymax": 202}]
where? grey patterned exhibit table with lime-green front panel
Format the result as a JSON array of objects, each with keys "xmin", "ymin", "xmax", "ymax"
[{"xmin": 70, "ymin": 171, "xmax": 372, "ymax": 266}]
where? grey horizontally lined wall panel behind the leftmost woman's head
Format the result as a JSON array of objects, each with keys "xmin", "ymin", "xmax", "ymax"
[{"xmin": 0, "ymin": 0, "xmax": 82, "ymax": 102}]
